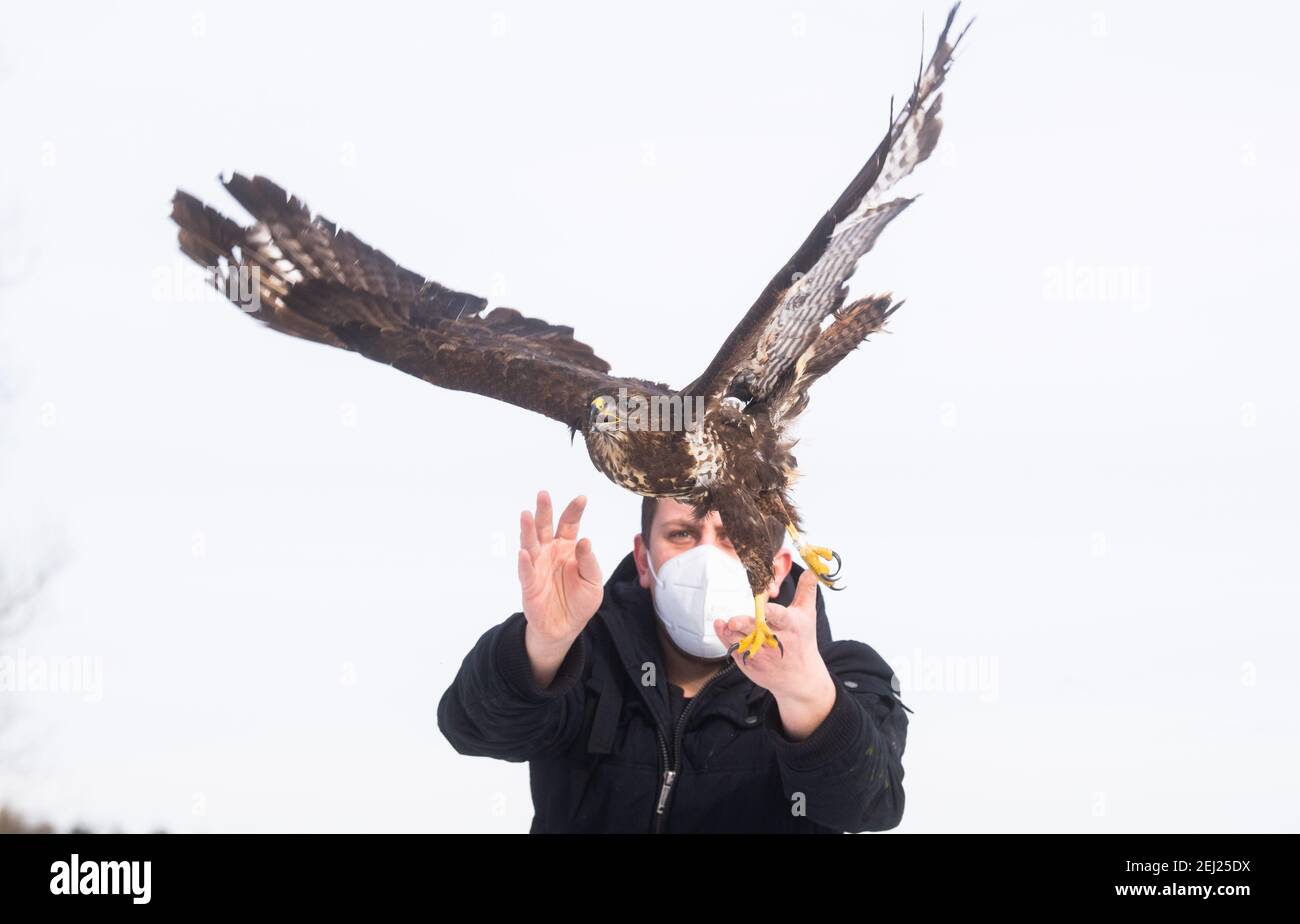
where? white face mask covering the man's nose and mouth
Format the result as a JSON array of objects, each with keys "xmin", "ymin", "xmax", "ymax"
[{"xmin": 646, "ymin": 543, "xmax": 754, "ymax": 658}]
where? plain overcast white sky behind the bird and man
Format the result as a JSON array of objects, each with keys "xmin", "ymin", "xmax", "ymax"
[{"xmin": 0, "ymin": 0, "xmax": 1300, "ymax": 832}]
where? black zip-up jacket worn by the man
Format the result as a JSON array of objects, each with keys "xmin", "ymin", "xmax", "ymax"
[{"xmin": 438, "ymin": 545, "xmax": 910, "ymax": 833}]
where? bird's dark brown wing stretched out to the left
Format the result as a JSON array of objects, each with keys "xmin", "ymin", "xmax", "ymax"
[{"xmin": 172, "ymin": 174, "xmax": 667, "ymax": 428}]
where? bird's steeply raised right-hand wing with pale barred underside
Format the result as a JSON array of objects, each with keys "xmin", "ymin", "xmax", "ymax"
[{"xmin": 683, "ymin": 4, "xmax": 970, "ymax": 402}]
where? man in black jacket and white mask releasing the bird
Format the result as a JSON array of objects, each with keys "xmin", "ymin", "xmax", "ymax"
[{"xmin": 438, "ymin": 491, "xmax": 907, "ymax": 833}]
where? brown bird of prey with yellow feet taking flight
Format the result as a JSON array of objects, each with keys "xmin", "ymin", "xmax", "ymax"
[{"xmin": 172, "ymin": 6, "xmax": 970, "ymax": 659}]
